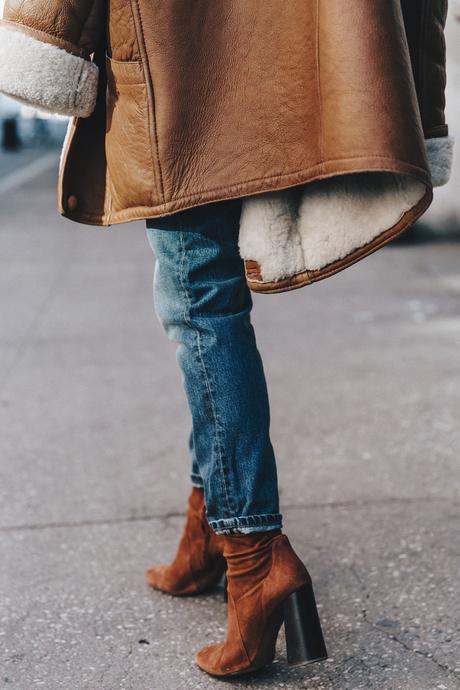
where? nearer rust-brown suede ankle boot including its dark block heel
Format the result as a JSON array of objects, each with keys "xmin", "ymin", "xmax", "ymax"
[{"xmin": 196, "ymin": 529, "xmax": 327, "ymax": 676}]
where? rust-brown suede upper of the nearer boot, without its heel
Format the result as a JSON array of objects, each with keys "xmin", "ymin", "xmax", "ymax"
[{"xmin": 195, "ymin": 530, "xmax": 311, "ymax": 677}]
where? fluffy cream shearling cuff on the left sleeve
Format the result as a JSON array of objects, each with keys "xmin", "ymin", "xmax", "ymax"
[{"xmin": 0, "ymin": 26, "xmax": 99, "ymax": 117}]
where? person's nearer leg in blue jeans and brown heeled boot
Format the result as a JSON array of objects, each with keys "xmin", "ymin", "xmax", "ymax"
[{"xmin": 144, "ymin": 202, "xmax": 327, "ymax": 677}]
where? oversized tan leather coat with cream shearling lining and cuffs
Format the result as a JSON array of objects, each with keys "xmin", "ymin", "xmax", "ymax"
[{"xmin": 0, "ymin": 0, "xmax": 452, "ymax": 292}]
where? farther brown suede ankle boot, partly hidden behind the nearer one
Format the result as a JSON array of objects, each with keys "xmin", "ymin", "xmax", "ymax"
[{"xmin": 144, "ymin": 486, "xmax": 225, "ymax": 596}]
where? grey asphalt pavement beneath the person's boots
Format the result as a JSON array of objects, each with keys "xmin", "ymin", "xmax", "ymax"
[{"xmin": 0, "ymin": 163, "xmax": 460, "ymax": 690}]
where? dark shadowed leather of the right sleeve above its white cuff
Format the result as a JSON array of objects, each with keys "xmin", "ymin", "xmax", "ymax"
[{"xmin": 401, "ymin": 0, "xmax": 448, "ymax": 139}]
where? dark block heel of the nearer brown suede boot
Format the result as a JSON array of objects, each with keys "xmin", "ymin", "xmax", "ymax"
[{"xmin": 283, "ymin": 583, "xmax": 327, "ymax": 665}]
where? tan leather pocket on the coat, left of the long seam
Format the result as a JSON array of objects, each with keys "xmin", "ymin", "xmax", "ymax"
[{"xmin": 106, "ymin": 56, "xmax": 161, "ymax": 213}]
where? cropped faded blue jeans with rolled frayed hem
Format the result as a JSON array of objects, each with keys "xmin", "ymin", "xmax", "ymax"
[{"xmin": 147, "ymin": 199, "xmax": 281, "ymax": 534}]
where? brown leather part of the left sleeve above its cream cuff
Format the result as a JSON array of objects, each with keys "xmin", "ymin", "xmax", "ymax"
[{"xmin": 2, "ymin": 0, "xmax": 105, "ymax": 57}]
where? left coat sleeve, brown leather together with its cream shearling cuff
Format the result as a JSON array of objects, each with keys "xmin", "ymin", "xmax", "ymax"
[{"xmin": 0, "ymin": 0, "xmax": 106, "ymax": 117}]
